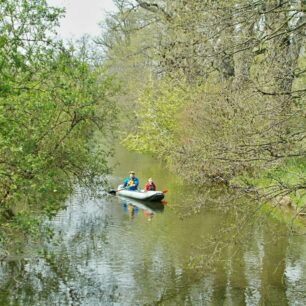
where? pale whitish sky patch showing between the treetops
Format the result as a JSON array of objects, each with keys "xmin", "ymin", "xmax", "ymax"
[{"xmin": 47, "ymin": 0, "xmax": 115, "ymax": 39}]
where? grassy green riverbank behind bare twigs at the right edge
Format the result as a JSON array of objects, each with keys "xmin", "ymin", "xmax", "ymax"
[{"xmin": 230, "ymin": 158, "xmax": 306, "ymax": 227}]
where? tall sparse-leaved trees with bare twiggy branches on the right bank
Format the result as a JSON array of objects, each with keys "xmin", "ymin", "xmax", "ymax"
[{"xmin": 101, "ymin": 0, "xmax": 306, "ymax": 195}]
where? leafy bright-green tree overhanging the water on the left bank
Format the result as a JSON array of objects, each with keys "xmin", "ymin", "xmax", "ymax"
[{"xmin": 0, "ymin": 0, "xmax": 115, "ymax": 238}]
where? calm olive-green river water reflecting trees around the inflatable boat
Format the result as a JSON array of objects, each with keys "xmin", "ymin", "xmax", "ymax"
[{"xmin": 0, "ymin": 151, "xmax": 306, "ymax": 306}]
